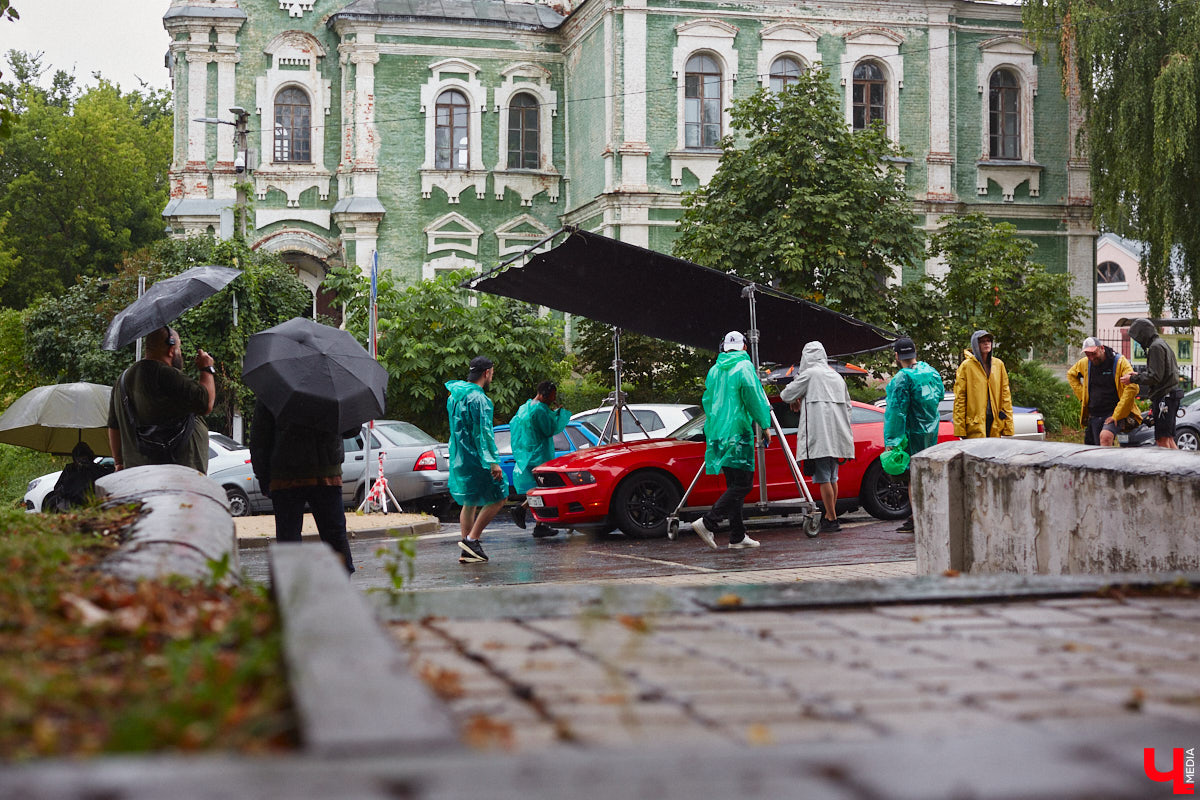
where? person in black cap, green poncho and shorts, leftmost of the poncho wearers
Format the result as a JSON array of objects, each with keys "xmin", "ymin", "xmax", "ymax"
[{"xmin": 446, "ymin": 355, "xmax": 509, "ymax": 564}]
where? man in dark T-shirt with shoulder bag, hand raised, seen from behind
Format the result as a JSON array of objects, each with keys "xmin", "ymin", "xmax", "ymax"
[{"xmin": 108, "ymin": 326, "xmax": 217, "ymax": 473}]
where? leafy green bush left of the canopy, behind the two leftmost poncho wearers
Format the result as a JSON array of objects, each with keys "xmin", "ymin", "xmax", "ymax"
[{"xmin": 323, "ymin": 267, "xmax": 568, "ymax": 437}]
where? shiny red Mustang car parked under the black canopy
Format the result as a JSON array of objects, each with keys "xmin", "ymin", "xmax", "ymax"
[{"xmin": 528, "ymin": 401, "xmax": 958, "ymax": 539}]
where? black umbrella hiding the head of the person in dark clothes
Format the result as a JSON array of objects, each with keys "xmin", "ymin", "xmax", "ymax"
[{"xmin": 241, "ymin": 318, "xmax": 388, "ymax": 433}]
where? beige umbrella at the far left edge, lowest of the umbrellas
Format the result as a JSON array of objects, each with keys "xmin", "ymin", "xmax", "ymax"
[{"xmin": 0, "ymin": 383, "xmax": 113, "ymax": 456}]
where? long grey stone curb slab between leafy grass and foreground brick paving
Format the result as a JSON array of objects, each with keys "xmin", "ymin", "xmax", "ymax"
[{"xmin": 270, "ymin": 542, "xmax": 460, "ymax": 757}]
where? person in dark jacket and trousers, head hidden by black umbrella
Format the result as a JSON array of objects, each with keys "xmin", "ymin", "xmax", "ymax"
[{"xmin": 250, "ymin": 402, "xmax": 356, "ymax": 572}]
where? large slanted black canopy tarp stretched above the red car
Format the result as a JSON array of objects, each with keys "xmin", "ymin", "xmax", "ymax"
[{"xmin": 466, "ymin": 230, "xmax": 896, "ymax": 363}]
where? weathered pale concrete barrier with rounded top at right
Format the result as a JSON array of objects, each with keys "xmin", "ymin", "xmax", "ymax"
[{"xmin": 912, "ymin": 439, "xmax": 1200, "ymax": 575}]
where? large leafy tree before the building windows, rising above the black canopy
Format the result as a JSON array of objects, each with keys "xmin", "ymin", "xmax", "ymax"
[{"xmin": 674, "ymin": 70, "xmax": 924, "ymax": 323}]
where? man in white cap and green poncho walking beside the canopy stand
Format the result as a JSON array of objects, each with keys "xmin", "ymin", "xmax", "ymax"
[{"xmin": 692, "ymin": 331, "xmax": 770, "ymax": 551}]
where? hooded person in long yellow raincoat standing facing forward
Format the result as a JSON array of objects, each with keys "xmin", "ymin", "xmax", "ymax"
[{"xmin": 954, "ymin": 331, "xmax": 1013, "ymax": 439}]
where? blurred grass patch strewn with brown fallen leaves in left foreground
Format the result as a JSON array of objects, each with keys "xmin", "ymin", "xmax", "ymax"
[{"xmin": 0, "ymin": 509, "xmax": 296, "ymax": 760}]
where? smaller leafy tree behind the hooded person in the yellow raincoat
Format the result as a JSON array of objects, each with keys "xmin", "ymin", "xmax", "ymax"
[{"xmin": 894, "ymin": 213, "xmax": 1085, "ymax": 380}]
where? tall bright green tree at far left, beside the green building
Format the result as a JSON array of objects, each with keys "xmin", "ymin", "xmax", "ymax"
[{"xmin": 0, "ymin": 52, "xmax": 172, "ymax": 308}]
